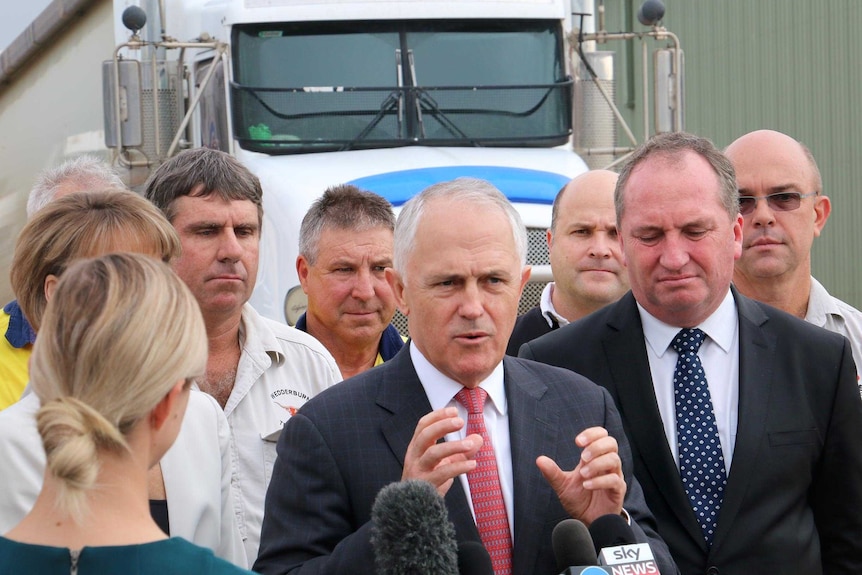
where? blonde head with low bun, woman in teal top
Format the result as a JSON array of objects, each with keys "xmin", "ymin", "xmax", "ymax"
[{"xmin": 30, "ymin": 253, "xmax": 207, "ymax": 519}]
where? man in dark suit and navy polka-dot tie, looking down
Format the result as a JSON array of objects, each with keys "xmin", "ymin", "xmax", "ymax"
[{"xmin": 520, "ymin": 130, "xmax": 862, "ymax": 575}]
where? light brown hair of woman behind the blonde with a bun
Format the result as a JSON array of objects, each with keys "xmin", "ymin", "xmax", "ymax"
[{"xmin": 10, "ymin": 189, "xmax": 180, "ymax": 331}]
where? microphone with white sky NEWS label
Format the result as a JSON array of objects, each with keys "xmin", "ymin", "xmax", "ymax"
[{"xmin": 590, "ymin": 514, "xmax": 660, "ymax": 575}]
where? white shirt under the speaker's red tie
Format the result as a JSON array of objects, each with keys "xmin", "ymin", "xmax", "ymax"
[{"xmin": 409, "ymin": 342, "xmax": 515, "ymax": 537}]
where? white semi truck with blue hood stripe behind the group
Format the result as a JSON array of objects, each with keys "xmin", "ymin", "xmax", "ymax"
[{"xmin": 103, "ymin": 0, "xmax": 683, "ymax": 323}]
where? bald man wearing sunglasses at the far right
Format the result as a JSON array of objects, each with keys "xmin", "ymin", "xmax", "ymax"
[{"xmin": 725, "ymin": 130, "xmax": 862, "ymax": 384}]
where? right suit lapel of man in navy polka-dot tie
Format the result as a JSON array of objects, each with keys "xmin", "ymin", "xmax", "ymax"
[{"xmin": 713, "ymin": 289, "xmax": 777, "ymax": 548}]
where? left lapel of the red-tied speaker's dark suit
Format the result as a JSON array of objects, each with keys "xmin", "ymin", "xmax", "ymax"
[{"xmin": 377, "ymin": 352, "xmax": 480, "ymax": 541}]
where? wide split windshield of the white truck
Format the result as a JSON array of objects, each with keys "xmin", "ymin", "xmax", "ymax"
[{"xmin": 231, "ymin": 20, "xmax": 572, "ymax": 154}]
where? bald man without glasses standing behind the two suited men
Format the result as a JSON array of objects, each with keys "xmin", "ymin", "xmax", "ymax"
[{"xmin": 506, "ymin": 170, "xmax": 629, "ymax": 355}]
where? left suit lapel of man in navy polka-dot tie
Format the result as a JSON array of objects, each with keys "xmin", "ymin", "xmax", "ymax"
[{"xmin": 602, "ymin": 292, "xmax": 706, "ymax": 549}]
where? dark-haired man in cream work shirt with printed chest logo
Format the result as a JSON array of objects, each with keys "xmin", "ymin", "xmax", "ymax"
[{"xmin": 145, "ymin": 148, "xmax": 341, "ymax": 561}]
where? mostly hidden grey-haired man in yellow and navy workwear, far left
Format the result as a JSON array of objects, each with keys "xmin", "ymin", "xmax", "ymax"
[{"xmin": 0, "ymin": 156, "xmax": 125, "ymax": 409}]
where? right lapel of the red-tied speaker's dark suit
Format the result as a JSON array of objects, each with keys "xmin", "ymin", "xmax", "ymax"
[{"xmin": 503, "ymin": 358, "xmax": 556, "ymax": 573}]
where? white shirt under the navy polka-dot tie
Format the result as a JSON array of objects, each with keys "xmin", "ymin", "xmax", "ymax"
[{"xmin": 638, "ymin": 290, "xmax": 739, "ymax": 474}]
